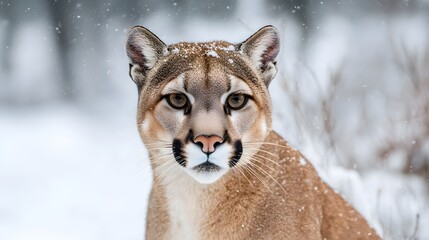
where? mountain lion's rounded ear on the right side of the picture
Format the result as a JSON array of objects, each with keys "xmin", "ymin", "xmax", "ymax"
[{"xmin": 239, "ymin": 25, "xmax": 280, "ymax": 86}]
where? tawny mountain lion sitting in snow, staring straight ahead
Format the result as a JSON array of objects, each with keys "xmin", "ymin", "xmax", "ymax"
[{"xmin": 126, "ymin": 26, "xmax": 379, "ymax": 240}]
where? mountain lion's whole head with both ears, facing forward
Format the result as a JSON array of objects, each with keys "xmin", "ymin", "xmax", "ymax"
[{"xmin": 127, "ymin": 27, "xmax": 279, "ymax": 184}]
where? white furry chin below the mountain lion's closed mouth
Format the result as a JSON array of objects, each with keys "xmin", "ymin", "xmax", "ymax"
[{"xmin": 186, "ymin": 166, "xmax": 228, "ymax": 184}]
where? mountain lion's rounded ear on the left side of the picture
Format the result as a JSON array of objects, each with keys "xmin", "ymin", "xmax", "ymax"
[{"xmin": 127, "ymin": 26, "xmax": 168, "ymax": 84}]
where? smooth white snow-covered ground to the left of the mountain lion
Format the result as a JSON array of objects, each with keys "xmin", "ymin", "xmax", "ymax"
[{"xmin": 0, "ymin": 103, "xmax": 151, "ymax": 240}]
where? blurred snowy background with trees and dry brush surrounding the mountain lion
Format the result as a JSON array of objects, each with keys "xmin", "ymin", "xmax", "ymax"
[{"xmin": 0, "ymin": 0, "xmax": 429, "ymax": 240}]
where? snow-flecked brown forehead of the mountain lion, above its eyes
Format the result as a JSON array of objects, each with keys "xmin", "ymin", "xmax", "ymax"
[{"xmin": 148, "ymin": 41, "xmax": 261, "ymax": 93}]
